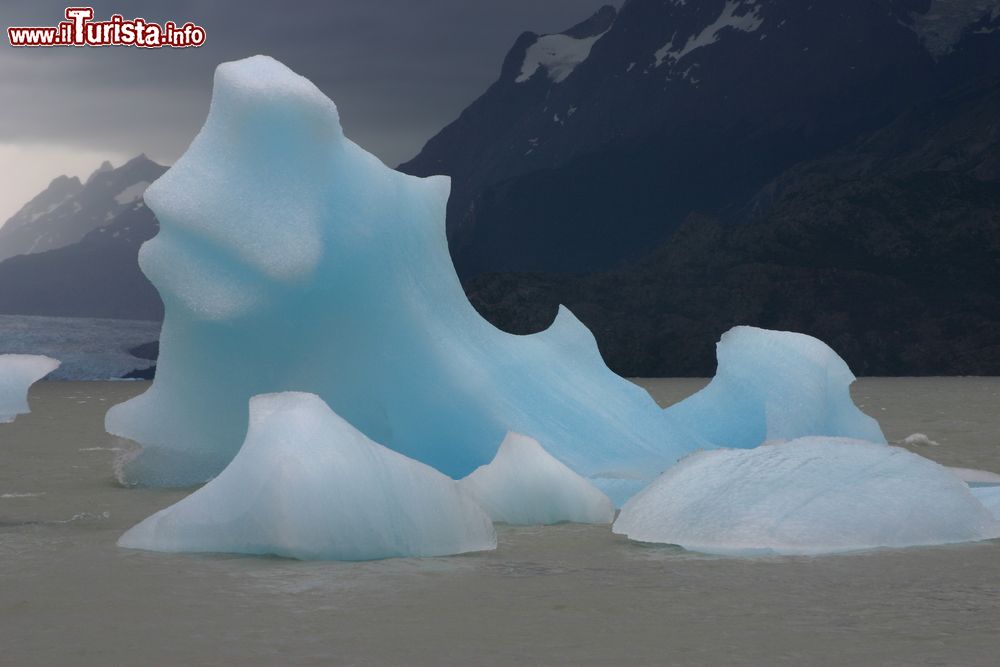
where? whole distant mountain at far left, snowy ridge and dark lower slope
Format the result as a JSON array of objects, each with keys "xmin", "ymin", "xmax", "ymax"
[{"xmin": 0, "ymin": 155, "xmax": 166, "ymax": 320}]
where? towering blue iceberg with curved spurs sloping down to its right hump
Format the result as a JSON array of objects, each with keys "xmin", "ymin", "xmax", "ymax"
[{"xmin": 106, "ymin": 56, "xmax": 877, "ymax": 502}]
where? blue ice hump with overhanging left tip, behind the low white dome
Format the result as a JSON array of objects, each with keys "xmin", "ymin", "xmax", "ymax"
[{"xmin": 668, "ymin": 327, "xmax": 885, "ymax": 447}]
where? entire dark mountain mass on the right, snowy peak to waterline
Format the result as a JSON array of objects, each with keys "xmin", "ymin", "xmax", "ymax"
[{"xmin": 400, "ymin": 0, "xmax": 1000, "ymax": 375}]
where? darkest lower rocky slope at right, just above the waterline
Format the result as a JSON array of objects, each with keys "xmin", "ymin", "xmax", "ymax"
[{"xmin": 466, "ymin": 64, "xmax": 1000, "ymax": 376}]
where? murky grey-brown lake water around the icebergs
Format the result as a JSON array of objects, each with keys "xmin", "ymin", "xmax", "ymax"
[{"xmin": 0, "ymin": 378, "xmax": 1000, "ymax": 666}]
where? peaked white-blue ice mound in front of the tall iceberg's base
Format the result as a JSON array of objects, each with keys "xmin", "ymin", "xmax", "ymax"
[{"xmin": 118, "ymin": 392, "xmax": 496, "ymax": 560}]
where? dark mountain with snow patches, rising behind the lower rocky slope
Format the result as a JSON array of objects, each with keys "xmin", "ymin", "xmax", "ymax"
[{"xmin": 400, "ymin": 0, "xmax": 1000, "ymax": 278}]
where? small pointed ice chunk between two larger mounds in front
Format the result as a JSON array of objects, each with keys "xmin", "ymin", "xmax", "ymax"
[{"xmin": 459, "ymin": 433, "xmax": 615, "ymax": 525}]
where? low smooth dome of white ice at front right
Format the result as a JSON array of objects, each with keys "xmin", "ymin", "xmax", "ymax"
[{"xmin": 614, "ymin": 437, "xmax": 1000, "ymax": 555}]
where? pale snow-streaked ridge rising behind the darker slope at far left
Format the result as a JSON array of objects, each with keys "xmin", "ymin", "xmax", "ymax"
[{"xmin": 0, "ymin": 155, "xmax": 166, "ymax": 261}]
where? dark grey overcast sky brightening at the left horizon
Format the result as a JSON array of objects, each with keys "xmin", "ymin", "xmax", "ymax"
[{"xmin": 0, "ymin": 0, "xmax": 620, "ymax": 222}]
